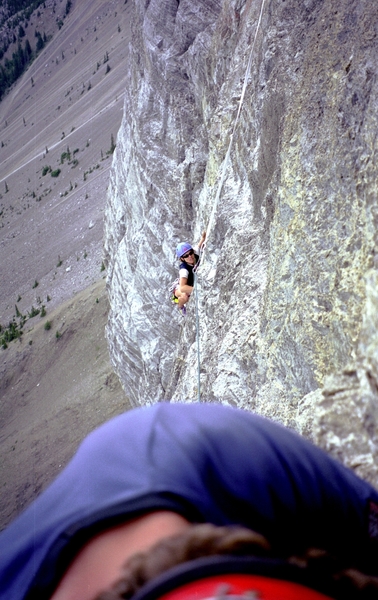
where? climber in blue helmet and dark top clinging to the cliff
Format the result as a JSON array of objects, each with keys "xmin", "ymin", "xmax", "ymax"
[{"xmin": 173, "ymin": 231, "xmax": 206, "ymax": 314}]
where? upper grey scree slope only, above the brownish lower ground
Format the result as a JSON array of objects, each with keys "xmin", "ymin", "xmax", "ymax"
[{"xmin": 0, "ymin": 0, "xmax": 128, "ymax": 323}]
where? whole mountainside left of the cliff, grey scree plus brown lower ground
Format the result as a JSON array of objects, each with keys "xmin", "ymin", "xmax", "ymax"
[{"xmin": 0, "ymin": 0, "xmax": 133, "ymax": 528}]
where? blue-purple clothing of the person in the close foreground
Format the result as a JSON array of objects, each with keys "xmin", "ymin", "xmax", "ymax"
[{"xmin": 0, "ymin": 403, "xmax": 378, "ymax": 600}]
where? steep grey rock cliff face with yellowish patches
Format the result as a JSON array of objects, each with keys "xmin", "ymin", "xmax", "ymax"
[{"xmin": 105, "ymin": 0, "xmax": 378, "ymax": 484}]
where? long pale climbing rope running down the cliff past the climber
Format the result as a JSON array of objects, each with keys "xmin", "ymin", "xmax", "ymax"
[{"xmin": 194, "ymin": 0, "xmax": 265, "ymax": 402}]
